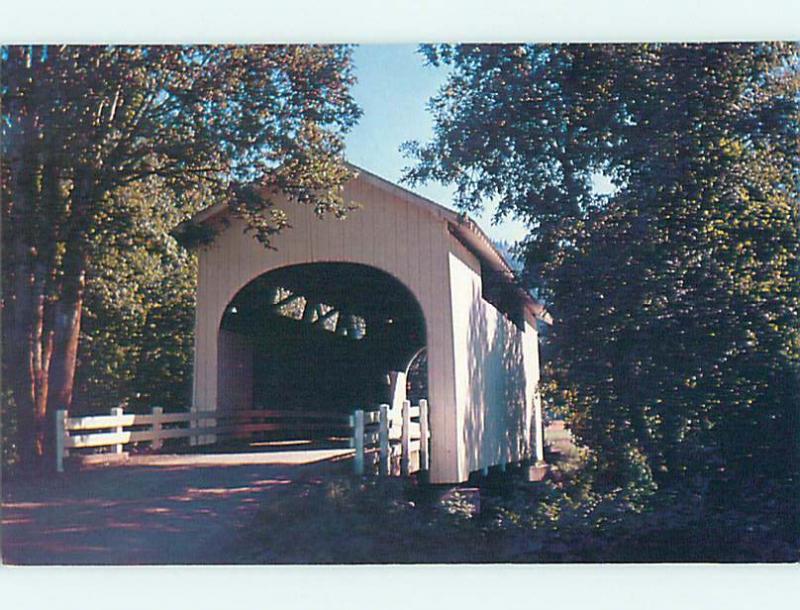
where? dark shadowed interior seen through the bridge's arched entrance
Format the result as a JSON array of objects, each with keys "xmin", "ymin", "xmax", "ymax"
[{"xmin": 221, "ymin": 263, "xmax": 427, "ymax": 413}]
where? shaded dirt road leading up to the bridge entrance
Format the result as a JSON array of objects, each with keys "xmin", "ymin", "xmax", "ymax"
[{"xmin": 2, "ymin": 449, "xmax": 351, "ymax": 565}]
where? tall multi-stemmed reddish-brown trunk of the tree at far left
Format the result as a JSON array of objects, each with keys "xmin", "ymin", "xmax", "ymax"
[{"xmin": 3, "ymin": 47, "xmax": 92, "ymax": 467}]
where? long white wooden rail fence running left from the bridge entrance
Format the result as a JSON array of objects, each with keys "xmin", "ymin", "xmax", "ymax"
[{"xmin": 56, "ymin": 407, "xmax": 351, "ymax": 472}]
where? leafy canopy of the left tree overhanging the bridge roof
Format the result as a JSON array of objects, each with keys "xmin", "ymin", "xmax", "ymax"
[{"xmin": 3, "ymin": 45, "xmax": 360, "ymax": 235}]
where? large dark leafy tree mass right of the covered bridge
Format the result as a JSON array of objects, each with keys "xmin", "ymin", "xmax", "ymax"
[{"xmin": 405, "ymin": 43, "xmax": 800, "ymax": 498}]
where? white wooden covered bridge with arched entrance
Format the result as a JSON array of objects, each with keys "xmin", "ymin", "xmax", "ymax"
[{"xmin": 181, "ymin": 168, "xmax": 547, "ymax": 483}]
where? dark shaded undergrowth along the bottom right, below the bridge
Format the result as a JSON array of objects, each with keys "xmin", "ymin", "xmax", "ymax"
[{"xmin": 236, "ymin": 452, "xmax": 800, "ymax": 564}]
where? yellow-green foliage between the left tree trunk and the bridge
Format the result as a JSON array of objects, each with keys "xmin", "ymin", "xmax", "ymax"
[{"xmin": 73, "ymin": 178, "xmax": 208, "ymax": 413}]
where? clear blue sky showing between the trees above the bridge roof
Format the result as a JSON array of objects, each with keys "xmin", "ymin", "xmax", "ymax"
[{"xmin": 347, "ymin": 45, "xmax": 526, "ymax": 242}]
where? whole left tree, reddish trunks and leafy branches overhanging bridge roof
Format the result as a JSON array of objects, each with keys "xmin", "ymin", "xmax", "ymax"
[{"xmin": 2, "ymin": 46, "xmax": 359, "ymax": 462}]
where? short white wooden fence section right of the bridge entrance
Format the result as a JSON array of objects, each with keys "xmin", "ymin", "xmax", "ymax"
[{"xmin": 350, "ymin": 399, "xmax": 430, "ymax": 476}]
